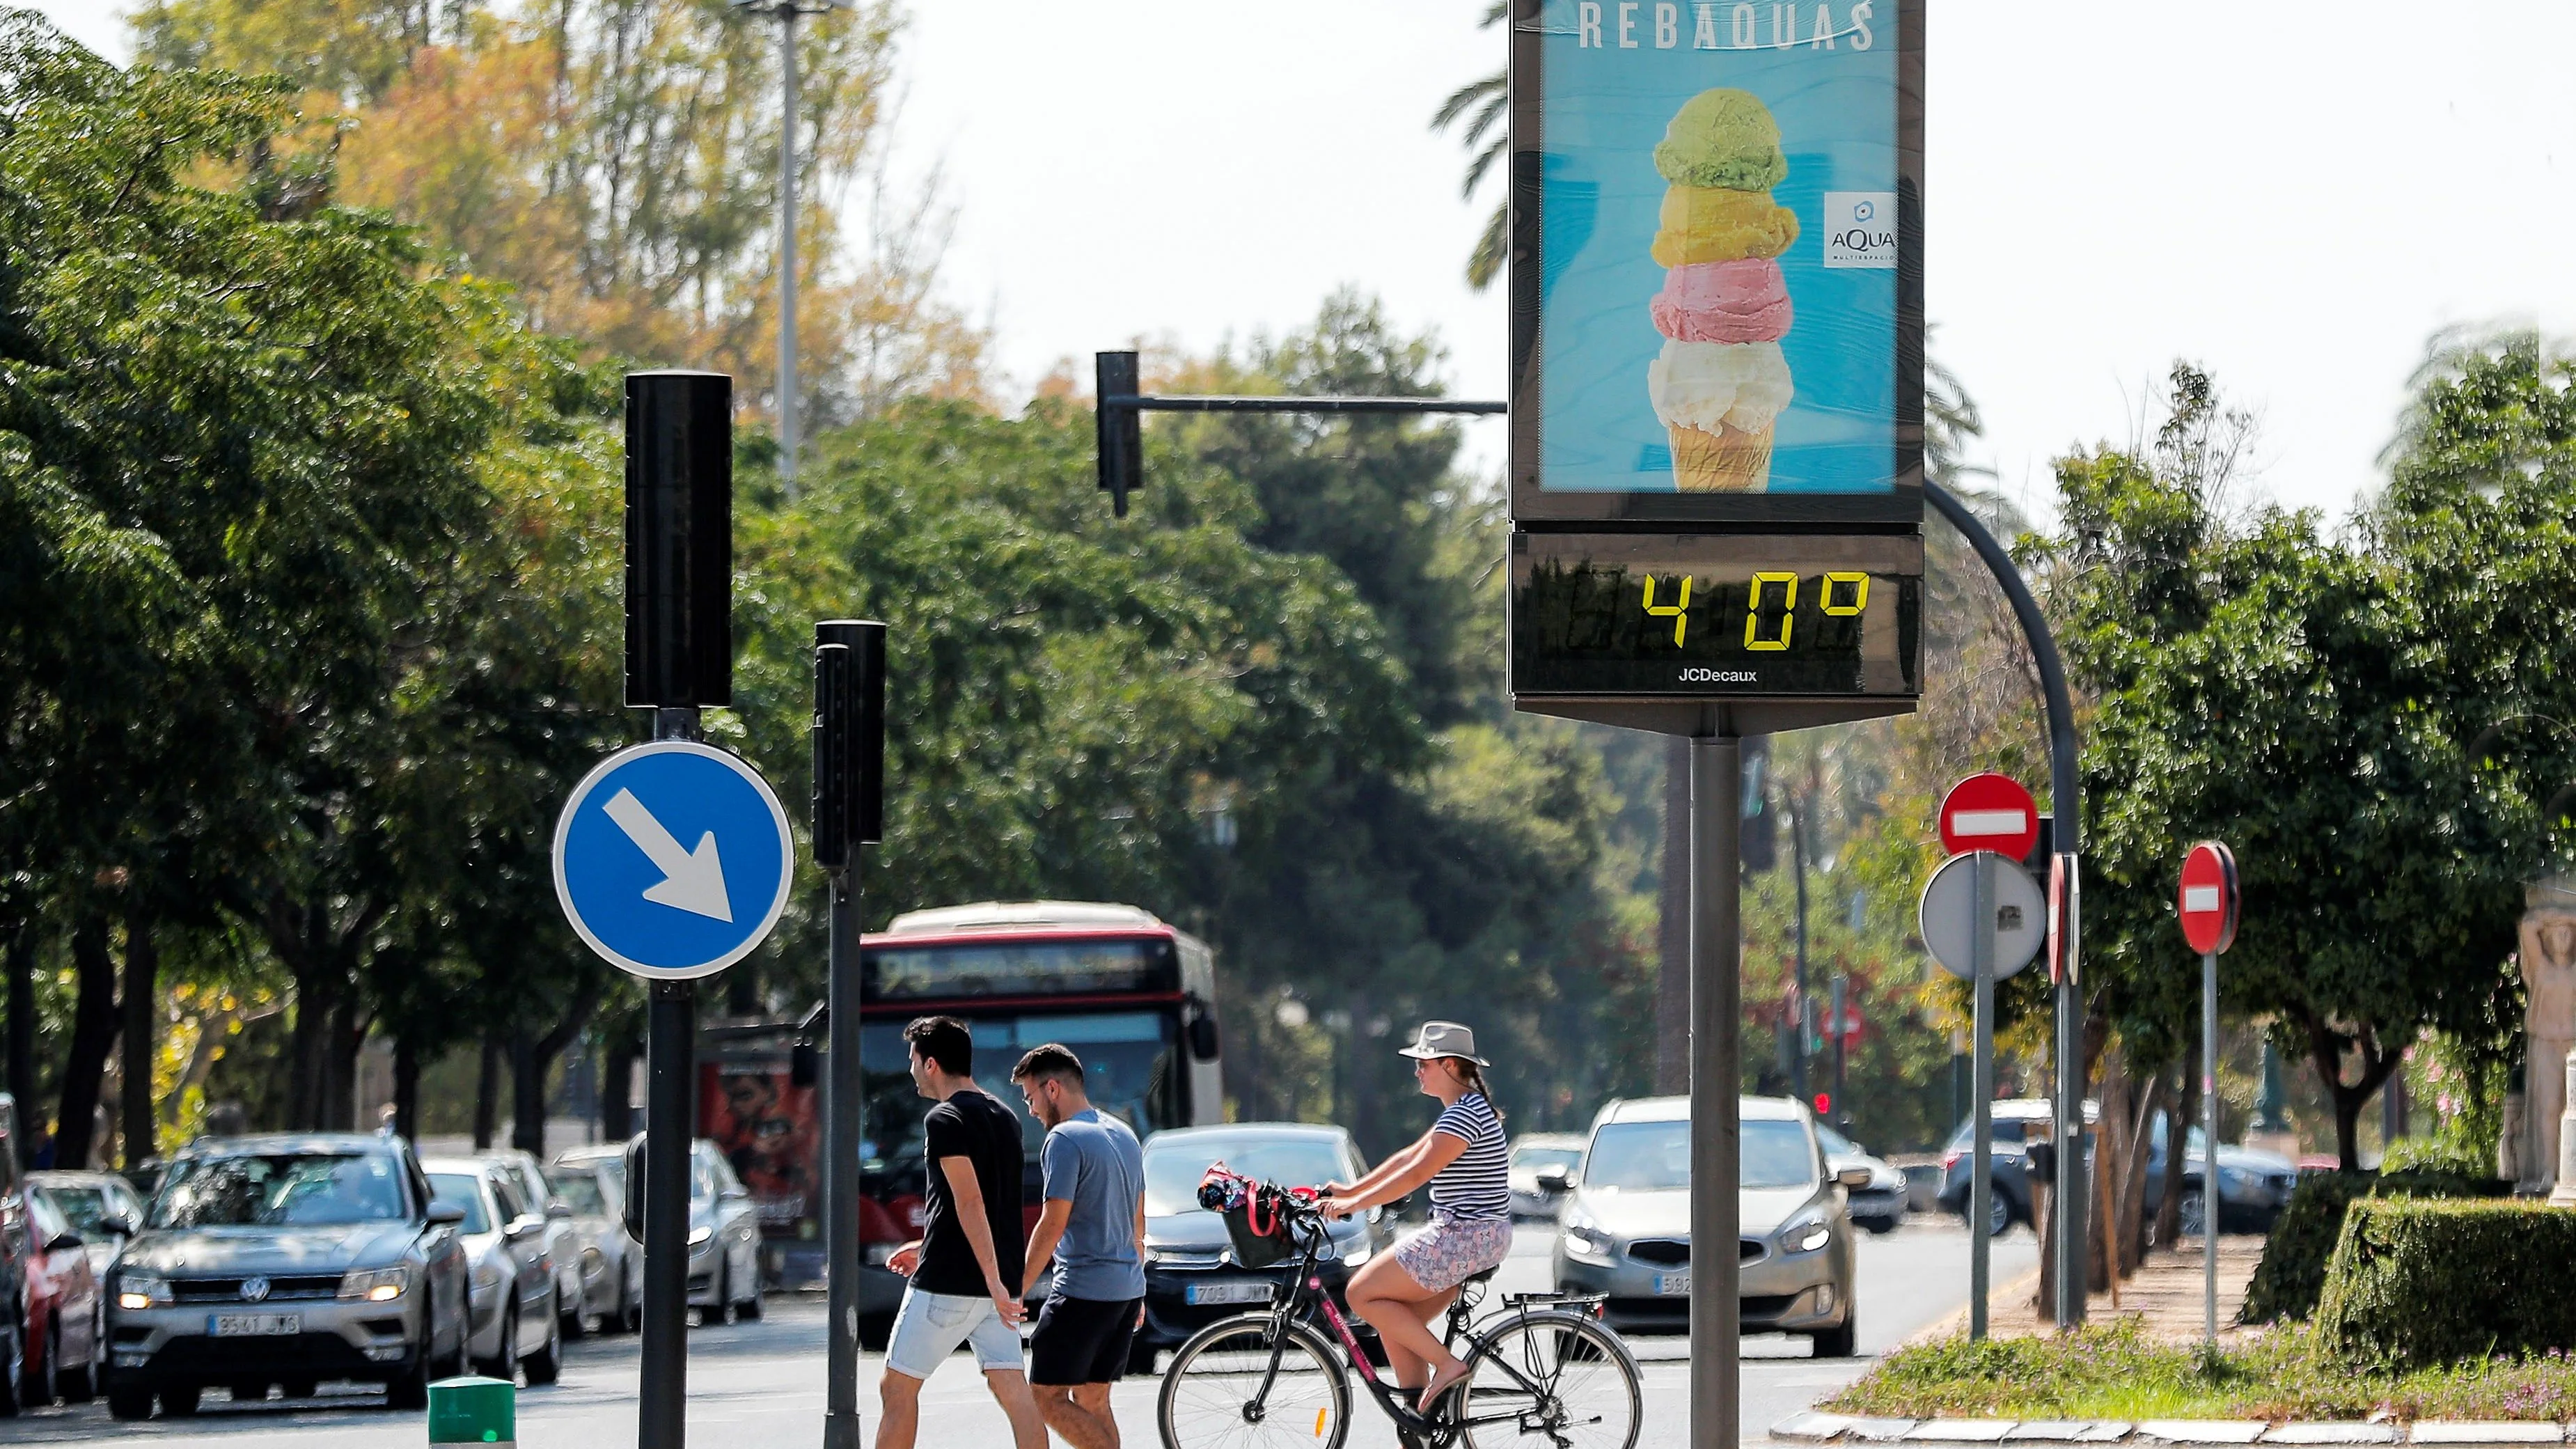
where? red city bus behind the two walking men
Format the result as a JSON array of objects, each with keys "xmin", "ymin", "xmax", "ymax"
[{"xmin": 858, "ymin": 900, "xmax": 1226, "ymax": 1346}]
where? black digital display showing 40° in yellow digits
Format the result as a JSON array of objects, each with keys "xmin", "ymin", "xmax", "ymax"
[{"xmin": 1512, "ymin": 533, "xmax": 1924, "ymax": 698}]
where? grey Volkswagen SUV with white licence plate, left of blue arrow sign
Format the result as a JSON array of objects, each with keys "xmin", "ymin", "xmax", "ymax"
[{"xmin": 108, "ymin": 1132, "xmax": 466, "ymax": 1418}]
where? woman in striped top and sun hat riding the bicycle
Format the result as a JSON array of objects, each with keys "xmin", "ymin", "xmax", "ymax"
[{"xmin": 1319, "ymin": 1021, "xmax": 1512, "ymax": 1413}]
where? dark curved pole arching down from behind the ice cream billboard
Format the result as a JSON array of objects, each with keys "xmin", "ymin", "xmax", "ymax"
[{"xmin": 1924, "ymin": 480, "xmax": 2087, "ymax": 1328}]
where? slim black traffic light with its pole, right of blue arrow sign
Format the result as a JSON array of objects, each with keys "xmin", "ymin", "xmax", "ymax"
[{"xmin": 814, "ymin": 619, "xmax": 886, "ymax": 1449}]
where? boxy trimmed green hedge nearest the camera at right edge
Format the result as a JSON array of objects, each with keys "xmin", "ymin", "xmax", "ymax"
[{"xmin": 2316, "ymin": 1196, "xmax": 2576, "ymax": 1369}]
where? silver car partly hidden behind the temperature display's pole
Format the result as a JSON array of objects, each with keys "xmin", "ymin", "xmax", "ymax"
[{"xmin": 1553, "ymin": 1096, "xmax": 1865, "ymax": 1358}]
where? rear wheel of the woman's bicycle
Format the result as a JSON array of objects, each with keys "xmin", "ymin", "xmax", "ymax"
[{"xmin": 1445, "ymin": 1310, "xmax": 1646, "ymax": 1449}]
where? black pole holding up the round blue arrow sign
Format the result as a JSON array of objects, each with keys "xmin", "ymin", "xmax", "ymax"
[{"xmin": 629, "ymin": 707, "xmax": 698, "ymax": 1449}]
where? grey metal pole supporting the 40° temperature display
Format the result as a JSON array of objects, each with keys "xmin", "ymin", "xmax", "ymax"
[{"xmin": 1690, "ymin": 735, "xmax": 1744, "ymax": 1449}]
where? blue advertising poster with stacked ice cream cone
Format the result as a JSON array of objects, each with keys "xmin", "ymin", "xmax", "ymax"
[{"xmin": 1509, "ymin": 0, "xmax": 1922, "ymax": 526}]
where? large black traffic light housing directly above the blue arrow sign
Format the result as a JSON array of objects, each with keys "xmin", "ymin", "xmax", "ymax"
[{"xmin": 626, "ymin": 371, "xmax": 735, "ymax": 709}]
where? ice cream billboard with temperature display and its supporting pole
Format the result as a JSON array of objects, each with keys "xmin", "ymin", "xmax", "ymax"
[{"xmin": 1504, "ymin": 0, "xmax": 1924, "ymax": 1449}]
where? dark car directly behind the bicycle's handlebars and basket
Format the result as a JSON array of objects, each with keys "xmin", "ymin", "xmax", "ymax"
[{"xmin": 1131, "ymin": 1122, "xmax": 1396, "ymax": 1374}]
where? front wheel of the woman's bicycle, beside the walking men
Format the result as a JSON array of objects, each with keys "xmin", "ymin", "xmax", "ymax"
[{"xmin": 1156, "ymin": 1313, "xmax": 1350, "ymax": 1449}]
